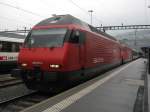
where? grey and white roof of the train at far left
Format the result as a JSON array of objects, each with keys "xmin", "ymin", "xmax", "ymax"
[{"xmin": 0, "ymin": 32, "xmax": 25, "ymax": 43}]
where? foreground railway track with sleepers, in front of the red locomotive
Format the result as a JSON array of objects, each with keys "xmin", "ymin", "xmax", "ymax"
[{"xmin": 0, "ymin": 91, "xmax": 52, "ymax": 112}]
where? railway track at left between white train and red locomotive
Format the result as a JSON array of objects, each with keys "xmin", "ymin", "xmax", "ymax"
[{"xmin": 0, "ymin": 75, "xmax": 23, "ymax": 88}]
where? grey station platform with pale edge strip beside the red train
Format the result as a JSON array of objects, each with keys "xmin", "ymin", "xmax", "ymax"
[{"xmin": 22, "ymin": 59, "xmax": 146, "ymax": 112}]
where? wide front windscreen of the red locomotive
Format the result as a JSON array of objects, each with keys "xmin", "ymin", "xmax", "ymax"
[{"xmin": 25, "ymin": 28, "xmax": 67, "ymax": 47}]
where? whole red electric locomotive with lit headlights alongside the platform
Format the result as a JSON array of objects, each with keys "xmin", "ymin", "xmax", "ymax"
[{"xmin": 14, "ymin": 15, "xmax": 130, "ymax": 90}]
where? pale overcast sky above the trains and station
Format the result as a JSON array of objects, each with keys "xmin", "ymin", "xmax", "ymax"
[{"xmin": 0, "ymin": 0, "xmax": 150, "ymax": 30}]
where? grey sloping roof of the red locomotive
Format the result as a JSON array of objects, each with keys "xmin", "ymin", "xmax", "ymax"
[{"xmin": 35, "ymin": 14, "xmax": 117, "ymax": 41}]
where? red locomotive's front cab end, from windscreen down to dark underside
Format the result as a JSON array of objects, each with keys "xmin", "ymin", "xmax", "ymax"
[{"xmin": 19, "ymin": 25, "xmax": 85, "ymax": 89}]
